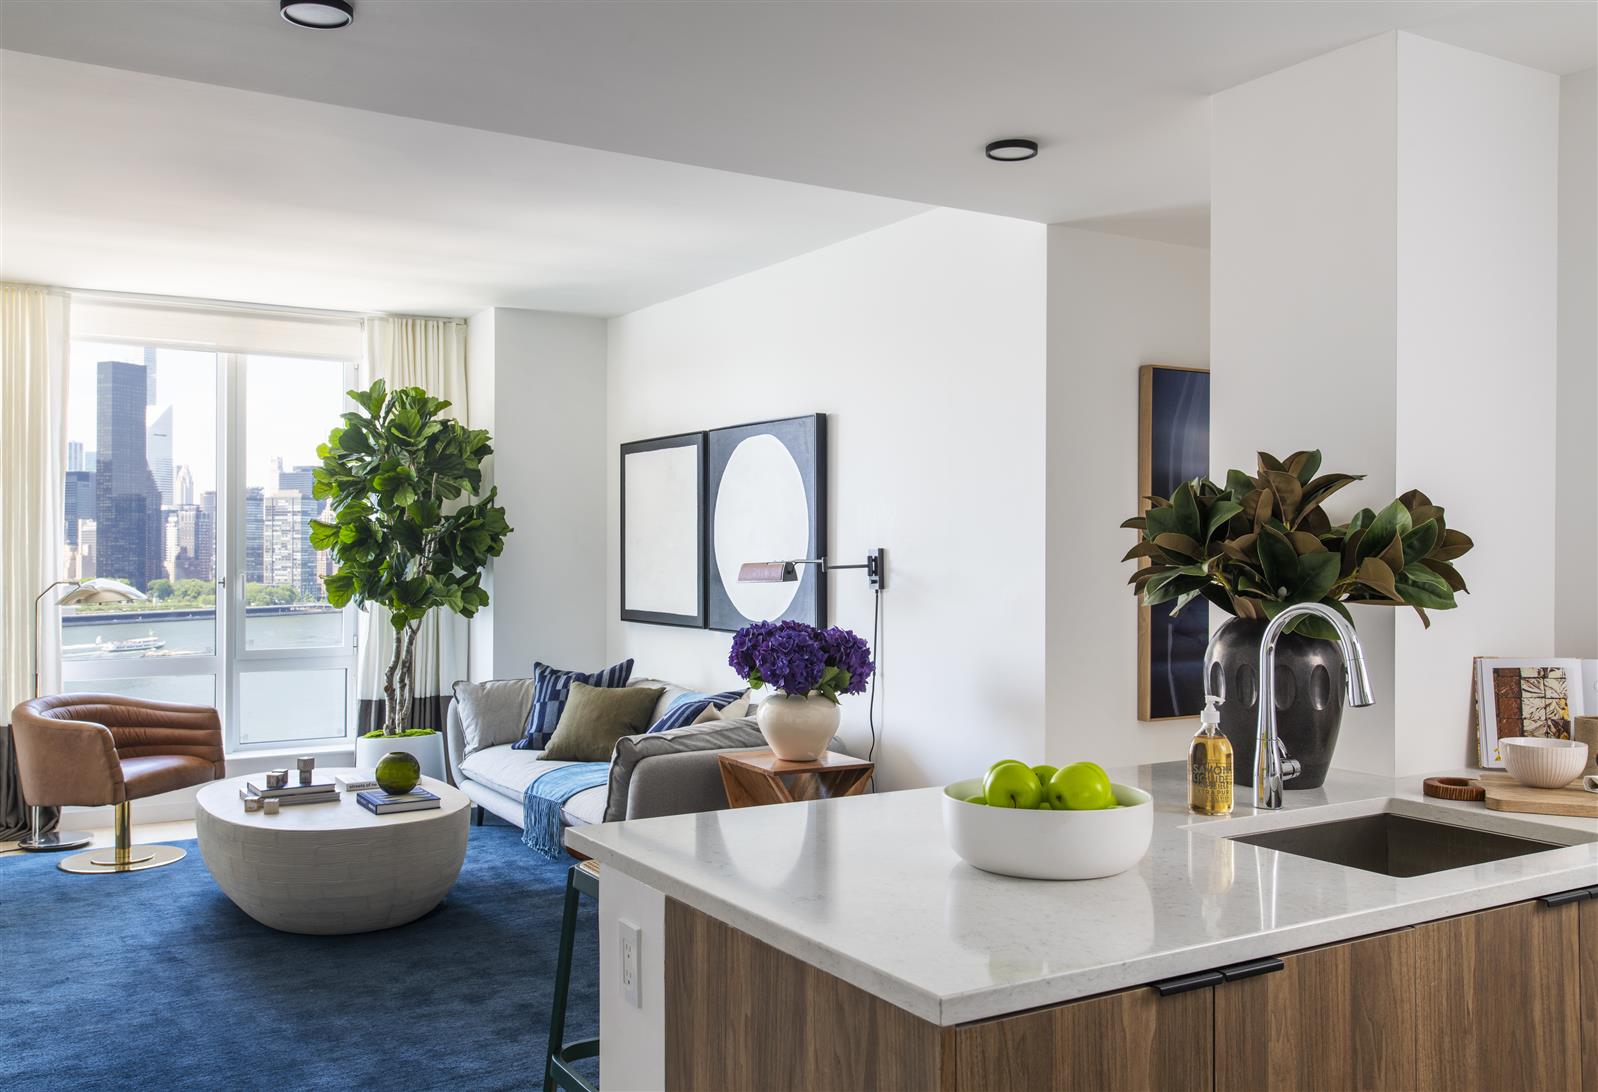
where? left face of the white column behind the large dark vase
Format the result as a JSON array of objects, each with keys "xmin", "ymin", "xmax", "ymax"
[{"xmin": 1210, "ymin": 35, "xmax": 1399, "ymax": 772}]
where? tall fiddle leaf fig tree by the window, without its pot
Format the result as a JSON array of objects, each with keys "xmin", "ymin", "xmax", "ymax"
[{"xmin": 310, "ymin": 379, "xmax": 511, "ymax": 735}]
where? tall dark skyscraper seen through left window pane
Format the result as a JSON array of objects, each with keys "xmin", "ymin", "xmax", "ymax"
[{"xmin": 95, "ymin": 360, "xmax": 165, "ymax": 592}]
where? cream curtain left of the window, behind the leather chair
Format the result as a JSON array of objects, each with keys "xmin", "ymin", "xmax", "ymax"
[{"xmin": 0, "ymin": 285, "xmax": 67, "ymax": 838}]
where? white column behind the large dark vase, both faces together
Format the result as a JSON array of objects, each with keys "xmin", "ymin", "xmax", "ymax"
[{"xmin": 1211, "ymin": 34, "xmax": 1558, "ymax": 774}]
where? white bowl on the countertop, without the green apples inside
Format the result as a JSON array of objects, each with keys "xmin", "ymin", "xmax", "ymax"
[{"xmin": 943, "ymin": 777, "xmax": 1154, "ymax": 879}]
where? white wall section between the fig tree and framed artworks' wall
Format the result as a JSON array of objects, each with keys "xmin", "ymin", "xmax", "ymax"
[{"xmin": 467, "ymin": 307, "xmax": 607, "ymax": 678}]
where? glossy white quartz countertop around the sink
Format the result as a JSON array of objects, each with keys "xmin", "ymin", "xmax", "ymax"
[{"xmin": 566, "ymin": 763, "xmax": 1598, "ymax": 1025}]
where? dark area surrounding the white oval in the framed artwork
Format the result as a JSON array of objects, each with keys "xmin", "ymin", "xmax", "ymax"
[{"xmin": 705, "ymin": 414, "xmax": 829, "ymax": 633}]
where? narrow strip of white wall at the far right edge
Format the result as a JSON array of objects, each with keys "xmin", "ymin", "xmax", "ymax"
[{"xmin": 1553, "ymin": 69, "xmax": 1598, "ymax": 657}]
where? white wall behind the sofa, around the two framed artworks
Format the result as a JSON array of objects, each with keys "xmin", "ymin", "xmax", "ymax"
[{"xmin": 606, "ymin": 209, "xmax": 1048, "ymax": 788}]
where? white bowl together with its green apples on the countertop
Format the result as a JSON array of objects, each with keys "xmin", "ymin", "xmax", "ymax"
[{"xmin": 943, "ymin": 759, "xmax": 1154, "ymax": 879}]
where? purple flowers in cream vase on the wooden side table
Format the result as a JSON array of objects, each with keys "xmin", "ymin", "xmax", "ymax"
[{"xmin": 727, "ymin": 622, "xmax": 876, "ymax": 763}]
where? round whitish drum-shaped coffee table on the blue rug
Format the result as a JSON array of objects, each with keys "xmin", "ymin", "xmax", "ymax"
[{"xmin": 195, "ymin": 769, "xmax": 471, "ymax": 934}]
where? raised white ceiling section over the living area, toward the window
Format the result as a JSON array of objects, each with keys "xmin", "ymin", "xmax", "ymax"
[{"xmin": 0, "ymin": 51, "xmax": 922, "ymax": 315}]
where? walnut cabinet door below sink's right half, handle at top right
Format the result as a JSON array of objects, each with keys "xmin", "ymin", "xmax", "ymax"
[{"xmin": 1411, "ymin": 902, "xmax": 1592, "ymax": 1092}]
